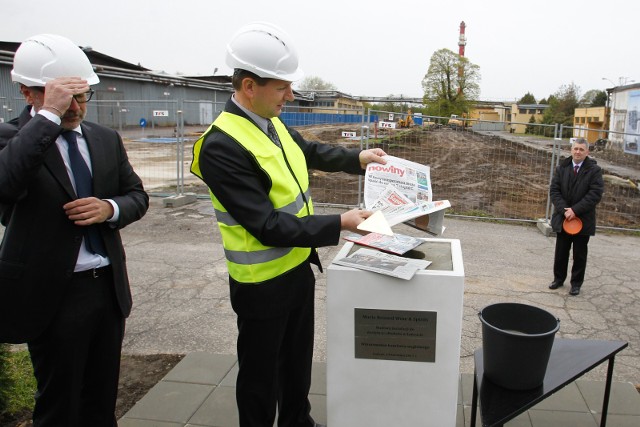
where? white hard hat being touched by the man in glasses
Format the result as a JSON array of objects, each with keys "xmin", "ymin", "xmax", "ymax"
[{"xmin": 11, "ymin": 34, "xmax": 100, "ymax": 86}]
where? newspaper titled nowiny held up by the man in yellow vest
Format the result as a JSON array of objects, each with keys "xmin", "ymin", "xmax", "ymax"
[{"xmin": 358, "ymin": 156, "xmax": 451, "ymax": 236}]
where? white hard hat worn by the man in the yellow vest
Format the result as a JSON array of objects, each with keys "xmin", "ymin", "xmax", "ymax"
[{"xmin": 227, "ymin": 22, "xmax": 304, "ymax": 82}]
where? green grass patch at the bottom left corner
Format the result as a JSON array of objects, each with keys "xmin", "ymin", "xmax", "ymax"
[{"xmin": 0, "ymin": 344, "xmax": 36, "ymax": 416}]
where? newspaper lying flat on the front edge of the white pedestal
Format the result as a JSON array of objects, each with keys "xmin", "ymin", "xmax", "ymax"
[{"xmin": 333, "ymin": 248, "xmax": 431, "ymax": 280}]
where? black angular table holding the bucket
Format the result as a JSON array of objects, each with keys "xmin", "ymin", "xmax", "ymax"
[{"xmin": 471, "ymin": 338, "xmax": 629, "ymax": 427}]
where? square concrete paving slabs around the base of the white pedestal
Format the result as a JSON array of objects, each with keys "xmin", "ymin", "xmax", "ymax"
[{"xmin": 119, "ymin": 353, "xmax": 640, "ymax": 427}]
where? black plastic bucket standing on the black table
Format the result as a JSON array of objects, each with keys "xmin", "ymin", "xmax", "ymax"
[{"xmin": 478, "ymin": 303, "xmax": 560, "ymax": 390}]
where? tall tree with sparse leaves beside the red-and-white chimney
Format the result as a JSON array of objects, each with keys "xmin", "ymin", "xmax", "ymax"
[{"xmin": 422, "ymin": 49, "xmax": 480, "ymax": 117}]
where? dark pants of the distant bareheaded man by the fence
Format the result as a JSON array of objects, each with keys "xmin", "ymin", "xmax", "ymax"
[{"xmin": 553, "ymin": 232, "xmax": 590, "ymax": 287}]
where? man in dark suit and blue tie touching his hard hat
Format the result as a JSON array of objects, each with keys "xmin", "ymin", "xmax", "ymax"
[{"xmin": 0, "ymin": 34, "xmax": 149, "ymax": 427}]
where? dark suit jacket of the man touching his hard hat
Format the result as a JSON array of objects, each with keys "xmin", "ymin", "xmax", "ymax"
[{"xmin": 0, "ymin": 107, "xmax": 149, "ymax": 343}]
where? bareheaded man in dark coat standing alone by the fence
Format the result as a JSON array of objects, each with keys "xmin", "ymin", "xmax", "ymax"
[{"xmin": 549, "ymin": 138, "xmax": 604, "ymax": 296}]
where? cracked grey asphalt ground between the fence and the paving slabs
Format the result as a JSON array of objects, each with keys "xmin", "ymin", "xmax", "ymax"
[{"xmin": 123, "ymin": 198, "xmax": 640, "ymax": 384}]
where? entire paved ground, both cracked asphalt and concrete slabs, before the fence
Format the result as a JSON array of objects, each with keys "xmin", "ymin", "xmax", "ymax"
[{"xmin": 120, "ymin": 198, "xmax": 640, "ymax": 427}]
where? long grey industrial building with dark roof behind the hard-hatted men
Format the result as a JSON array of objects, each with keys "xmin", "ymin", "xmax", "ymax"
[{"xmin": 0, "ymin": 41, "xmax": 311, "ymax": 130}]
